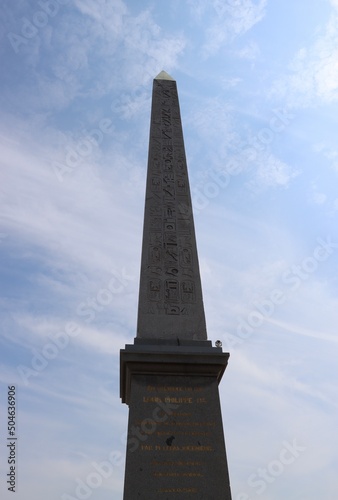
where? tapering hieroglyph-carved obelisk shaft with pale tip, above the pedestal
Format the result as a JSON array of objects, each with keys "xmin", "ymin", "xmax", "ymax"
[{"xmin": 137, "ymin": 72, "xmax": 207, "ymax": 340}]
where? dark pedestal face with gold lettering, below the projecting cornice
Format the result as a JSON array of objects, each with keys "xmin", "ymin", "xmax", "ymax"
[{"xmin": 124, "ymin": 375, "xmax": 231, "ymax": 500}]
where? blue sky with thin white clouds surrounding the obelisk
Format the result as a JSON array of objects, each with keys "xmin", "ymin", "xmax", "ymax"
[{"xmin": 0, "ymin": 0, "xmax": 338, "ymax": 500}]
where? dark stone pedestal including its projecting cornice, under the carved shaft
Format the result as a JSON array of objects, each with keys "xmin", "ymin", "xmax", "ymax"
[{"xmin": 121, "ymin": 339, "xmax": 231, "ymax": 500}]
